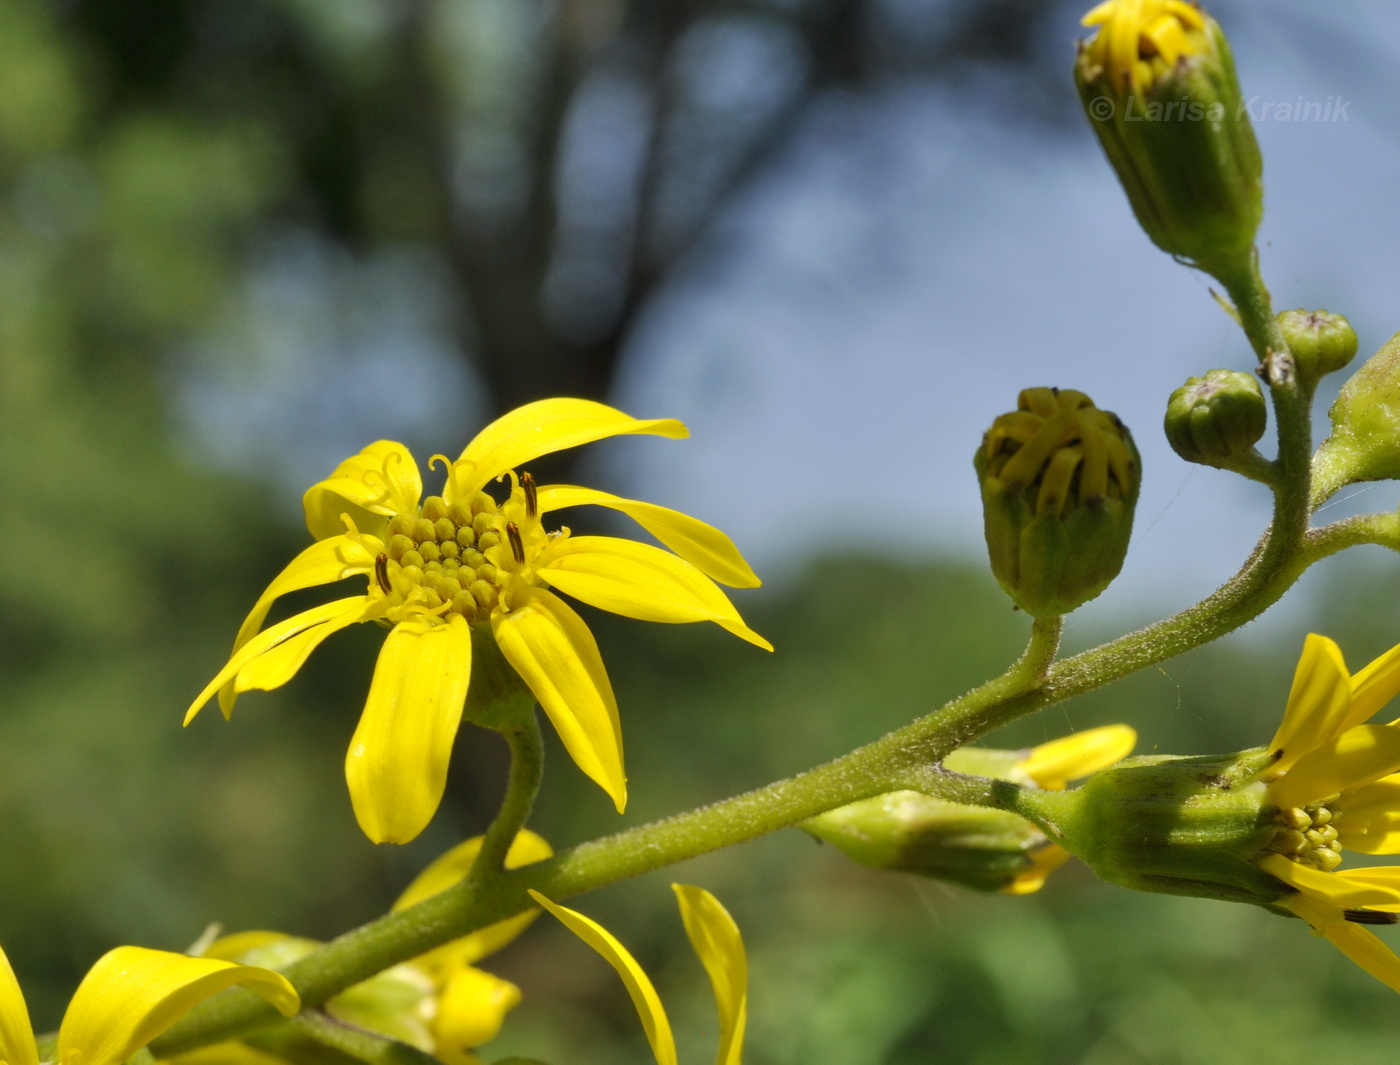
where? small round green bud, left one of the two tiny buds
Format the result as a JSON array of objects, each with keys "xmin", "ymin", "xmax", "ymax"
[{"xmin": 1163, "ymin": 369, "xmax": 1267, "ymax": 466}]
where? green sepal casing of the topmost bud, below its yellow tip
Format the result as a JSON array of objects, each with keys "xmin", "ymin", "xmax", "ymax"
[{"xmin": 1074, "ymin": 15, "xmax": 1264, "ymax": 276}]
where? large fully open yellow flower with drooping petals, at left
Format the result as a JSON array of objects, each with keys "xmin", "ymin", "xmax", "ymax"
[{"xmin": 185, "ymin": 399, "xmax": 773, "ymax": 842}]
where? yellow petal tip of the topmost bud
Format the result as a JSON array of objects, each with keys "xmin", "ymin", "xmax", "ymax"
[{"xmin": 1084, "ymin": 0, "xmax": 1208, "ymax": 95}]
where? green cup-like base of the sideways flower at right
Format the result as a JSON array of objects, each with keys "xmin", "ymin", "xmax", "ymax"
[{"xmin": 1025, "ymin": 749, "xmax": 1292, "ymax": 908}]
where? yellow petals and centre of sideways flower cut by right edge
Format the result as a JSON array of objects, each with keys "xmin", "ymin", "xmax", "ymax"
[{"xmin": 1256, "ymin": 634, "xmax": 1400, "ymax": 991}]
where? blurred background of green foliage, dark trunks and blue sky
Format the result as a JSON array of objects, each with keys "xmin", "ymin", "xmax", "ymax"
[{"xmin": 0, "ymin": 0, "xmax": 1400, "ymax": 1065}]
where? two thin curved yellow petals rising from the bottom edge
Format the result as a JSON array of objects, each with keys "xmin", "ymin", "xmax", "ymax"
[{"xmin": 531, "ymin": 884, "xmax": 749, "ymax": 1065}]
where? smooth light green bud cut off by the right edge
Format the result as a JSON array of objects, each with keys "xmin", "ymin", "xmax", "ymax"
[{"xmin": 1313, "ymin": 333, "xmax": 1400, "ymax": 494}]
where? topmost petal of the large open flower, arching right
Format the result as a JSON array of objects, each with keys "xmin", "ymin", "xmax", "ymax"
[{"xmin": 458, "ymin": 399, "xmax": 690, "ymax": 491}]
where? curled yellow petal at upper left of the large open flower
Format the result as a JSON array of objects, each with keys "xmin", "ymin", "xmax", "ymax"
[{"xmin": 301, "ymin": 439, "xmax": 423, "ymax": 540}]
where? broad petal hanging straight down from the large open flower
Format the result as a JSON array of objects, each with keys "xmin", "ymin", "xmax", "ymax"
[{"xmin": 346, "ymin": 614, "xmax": 472, "ymax": 842}]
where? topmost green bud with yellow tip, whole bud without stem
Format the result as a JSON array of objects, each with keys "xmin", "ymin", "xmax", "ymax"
[{"xmin": 1074, "ymin": 0, "xmax": 1264, "ymax": 273}]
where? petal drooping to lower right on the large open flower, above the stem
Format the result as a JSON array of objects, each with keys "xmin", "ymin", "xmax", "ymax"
[{"xmin": 491, "ymin": 588, "xmax": 627, "ymax": 813}]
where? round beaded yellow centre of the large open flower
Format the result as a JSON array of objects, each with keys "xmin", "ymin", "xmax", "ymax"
[{"xmin": 370, "ymin": 473, "xmax": 567, "ymax": 624}]
